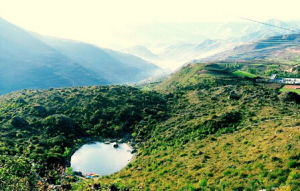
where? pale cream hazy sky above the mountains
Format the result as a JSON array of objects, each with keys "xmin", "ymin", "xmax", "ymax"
[{"xmin": 0, "ymin": 0, "xmax": 300, "ymax": 47}]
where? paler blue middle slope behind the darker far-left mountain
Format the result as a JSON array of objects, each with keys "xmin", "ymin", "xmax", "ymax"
[{"xmin": 38, "ymin": 36, "xmax": 159, "ymax": 83}]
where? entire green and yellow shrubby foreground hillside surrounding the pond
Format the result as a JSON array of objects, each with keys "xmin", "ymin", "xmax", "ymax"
[{"xmin": 0, "ymin": 63, "xmax": 300, "ymax": 190}]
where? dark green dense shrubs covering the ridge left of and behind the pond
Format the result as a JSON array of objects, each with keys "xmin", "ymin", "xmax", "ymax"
[{"xmin": 0, "ymin": 86, "xmax": 166, "ymax": 189}]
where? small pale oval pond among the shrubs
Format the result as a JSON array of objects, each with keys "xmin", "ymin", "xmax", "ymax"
[{"xmin": 71, "ymin": 142, "xmax": 133, "ymax": 176}]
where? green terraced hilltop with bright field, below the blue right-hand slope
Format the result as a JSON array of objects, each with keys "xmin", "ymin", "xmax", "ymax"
[{"xmin": 156, "ymin": 60, "xmax": 300, "ymax": 91}]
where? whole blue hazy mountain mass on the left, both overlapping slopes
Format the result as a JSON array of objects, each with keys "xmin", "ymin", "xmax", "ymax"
[{"xmin": 0, "ymin": 19, "xmax": 159, "ymax": 94}]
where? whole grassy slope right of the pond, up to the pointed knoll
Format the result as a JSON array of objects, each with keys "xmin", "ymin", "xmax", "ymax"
[{"xmin": 77, "ymin": 64, "xmax": 300, "ymax": 190}]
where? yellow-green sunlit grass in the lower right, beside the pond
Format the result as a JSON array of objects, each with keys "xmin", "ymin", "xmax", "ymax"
[{"xmin": 86, "ymin": 113, "xmax": 300, "ymax": 190}]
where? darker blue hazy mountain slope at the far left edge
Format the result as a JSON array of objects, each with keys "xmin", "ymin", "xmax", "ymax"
[{"xmin": 0, "ymin": 17, "xmax": 109, "ymax": 94}]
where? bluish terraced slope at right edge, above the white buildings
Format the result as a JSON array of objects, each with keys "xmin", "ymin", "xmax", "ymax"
[{"xmin": 202, "ymin": 34, "xmax": 300, "ymax": 62}]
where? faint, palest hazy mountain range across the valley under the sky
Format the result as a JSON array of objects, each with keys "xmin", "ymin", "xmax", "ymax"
[{"xmin": 122, "ymin": 19, "xmax": 300, "ymax": 70}]
